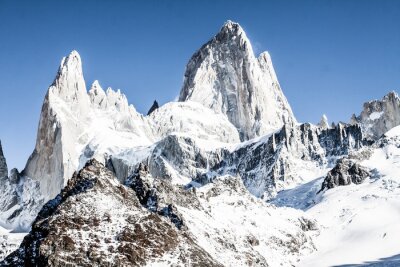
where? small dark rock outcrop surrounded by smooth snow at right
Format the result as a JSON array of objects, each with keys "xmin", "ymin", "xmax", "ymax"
[{"xmin": 320, "ymin": 159, "xmax": 371, "ymax": 192}]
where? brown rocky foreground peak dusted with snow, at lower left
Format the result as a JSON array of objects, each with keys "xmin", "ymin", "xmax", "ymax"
[{"xmin": 2, "ymin": 160, "xmax": 221, "ymax": 266}]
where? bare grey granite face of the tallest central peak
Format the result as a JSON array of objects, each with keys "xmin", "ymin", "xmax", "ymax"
[{"xmin": 179, "ymin": 21, "xmax": 295, "ymax": 140}]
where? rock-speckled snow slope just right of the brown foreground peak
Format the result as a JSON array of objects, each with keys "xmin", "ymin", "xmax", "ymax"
[{"xmin": 178, "ymin": 176, "xmax": 315, "ymax": 266}]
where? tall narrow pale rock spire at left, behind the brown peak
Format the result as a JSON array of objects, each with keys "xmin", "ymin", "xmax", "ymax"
[{"xmin": 23, "ymin": 51, "xmax": 89, "ymax": 201}]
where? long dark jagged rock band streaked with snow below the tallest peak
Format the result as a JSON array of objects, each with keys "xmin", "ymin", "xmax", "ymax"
[{"xmin": 107, "ymin": 120, "xmax": 369, "ymax": 199}]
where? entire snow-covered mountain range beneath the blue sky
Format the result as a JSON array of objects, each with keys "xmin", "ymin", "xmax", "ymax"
[{"xmin": 0, "ymin": 21, "xmax": 400, "ymax": 266}]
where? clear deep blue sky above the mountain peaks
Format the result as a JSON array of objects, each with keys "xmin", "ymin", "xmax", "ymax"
[{"xmin": 0, "ymin": 0, "xmax": 400, "ymax": 172}]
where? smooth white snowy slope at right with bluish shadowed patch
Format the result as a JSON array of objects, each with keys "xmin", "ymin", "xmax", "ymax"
[{"xmin": 273, "ymin": 127, "xmax": 400, "ymax": 266}]
